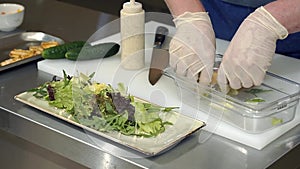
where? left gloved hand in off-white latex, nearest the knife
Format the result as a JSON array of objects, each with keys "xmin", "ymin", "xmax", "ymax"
[{"xmin": 169, "ymin": 12, "xmax": 216, "ymax": 85}]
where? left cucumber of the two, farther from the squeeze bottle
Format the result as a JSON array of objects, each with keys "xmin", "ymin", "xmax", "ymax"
[{"xmin": 42, "ymin": 41, "xmax": 85, "ymax": 59}]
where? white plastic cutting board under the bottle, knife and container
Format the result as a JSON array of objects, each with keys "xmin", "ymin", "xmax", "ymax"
[{"xmin": 38, "ymin": 21, "xmax": 300, "ymax": 150}]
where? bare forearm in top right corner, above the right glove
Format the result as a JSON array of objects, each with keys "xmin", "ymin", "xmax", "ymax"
[{"xmin": 264, "ymin": 0, "xmax": 300, "ymax": 33}]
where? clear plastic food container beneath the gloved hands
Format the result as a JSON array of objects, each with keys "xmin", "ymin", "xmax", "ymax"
[{"xmin": 164, "ymin": 56, "xmax": 300, "ymax": 133}]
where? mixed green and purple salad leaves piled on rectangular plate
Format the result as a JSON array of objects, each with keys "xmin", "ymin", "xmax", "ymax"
[{"xmin": 28, "ymin": 71, "xmax": 177, "ymax": 137}]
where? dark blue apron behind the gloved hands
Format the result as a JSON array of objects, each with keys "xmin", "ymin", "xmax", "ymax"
[{"xmin": 201, "ymin": 0, "xmax": 300, "ymax": 59}]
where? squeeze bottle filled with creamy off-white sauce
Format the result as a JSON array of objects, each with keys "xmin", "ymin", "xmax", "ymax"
[{"xmin": 120, "ymin": 0, "xmax": 145, "ymax": 70}]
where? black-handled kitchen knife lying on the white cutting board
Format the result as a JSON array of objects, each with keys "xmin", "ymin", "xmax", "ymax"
[{"xmin": 148, "ymin": 26, "xmax": 169, "ymax": 85}]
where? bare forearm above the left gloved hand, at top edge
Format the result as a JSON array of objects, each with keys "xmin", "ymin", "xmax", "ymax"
[{"xmin": 165, "ymin": 0, "xmax": 205, "ymax": 16}]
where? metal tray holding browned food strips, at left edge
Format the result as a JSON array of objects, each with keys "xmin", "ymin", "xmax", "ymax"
[{"xmin": 0, "ymin": 32, "xmax": 64, "ymax": 72}]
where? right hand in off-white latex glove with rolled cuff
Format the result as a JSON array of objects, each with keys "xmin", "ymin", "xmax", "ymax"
[{"xmin": 217, "ymin": 7, "xmax": 288, "ymax": 92}]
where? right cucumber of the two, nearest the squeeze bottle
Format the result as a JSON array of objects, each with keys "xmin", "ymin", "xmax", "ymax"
[{"xmin": 65, "ymin": 42, "xmax": 120, "ymax": 60}]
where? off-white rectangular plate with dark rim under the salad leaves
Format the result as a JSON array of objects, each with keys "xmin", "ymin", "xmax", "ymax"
[{"xmin": 15, "ymin": 92, "xmax": 205, "ymax": 156}]
